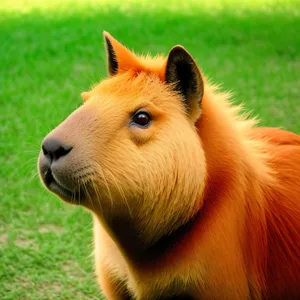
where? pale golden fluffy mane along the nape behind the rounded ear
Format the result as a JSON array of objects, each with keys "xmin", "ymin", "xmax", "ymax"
[{"xmin": 196, "ymin": 78, "xmax": 276, "ymax": 182}]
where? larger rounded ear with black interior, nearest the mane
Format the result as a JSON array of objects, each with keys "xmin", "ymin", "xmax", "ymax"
[{"xmin": 165, "ymin": 46, "xmax": 204, "ymax": 114}]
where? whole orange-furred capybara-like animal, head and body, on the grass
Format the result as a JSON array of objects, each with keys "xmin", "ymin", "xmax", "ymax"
[{"xmin": 39, "ymin": 33, "xmax": 300, "ymax": 300}]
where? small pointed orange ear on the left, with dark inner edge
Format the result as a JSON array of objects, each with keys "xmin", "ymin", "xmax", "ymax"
[{"xmin": 103, "ymin": 31, "xmax": 139, "ymax": 76}]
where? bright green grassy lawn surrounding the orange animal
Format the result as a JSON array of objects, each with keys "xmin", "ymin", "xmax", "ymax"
[{"xmin": 0, "ymin": 0, "xmax": 300, "ymax": 300}]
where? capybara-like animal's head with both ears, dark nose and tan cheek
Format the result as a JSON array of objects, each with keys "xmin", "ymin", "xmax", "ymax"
[{"xmin": 38, "ymin": 32, "xmax": 205, "ymax": 244}]
